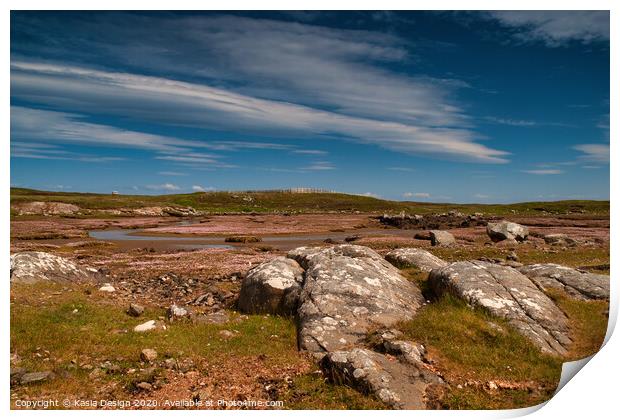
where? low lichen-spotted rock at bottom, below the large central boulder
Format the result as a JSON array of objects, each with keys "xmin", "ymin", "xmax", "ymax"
[{"xmin": 320, "ymin": 348, "xmax": 441, "ymax": 410}]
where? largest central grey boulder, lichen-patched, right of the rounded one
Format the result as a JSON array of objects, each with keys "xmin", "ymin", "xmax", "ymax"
[{"xmin": 298, "ymin": 245, "xmax": 424, "ymax": 357}]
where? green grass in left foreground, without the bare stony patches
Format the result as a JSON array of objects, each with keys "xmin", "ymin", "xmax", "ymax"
[{"xmin": 10, "ymin": 284, "xmax": 382, "ymax": 409}]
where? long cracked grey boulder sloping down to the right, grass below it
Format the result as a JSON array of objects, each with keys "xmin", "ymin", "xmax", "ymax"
[{"xmin": 428, "ymin": 261, "xmax": 571, "ymax": 355}]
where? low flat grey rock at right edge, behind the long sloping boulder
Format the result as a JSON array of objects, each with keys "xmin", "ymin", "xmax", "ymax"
[{"xmin": 518, "ymin": 264, "xmax": 609, "ymax": 300}]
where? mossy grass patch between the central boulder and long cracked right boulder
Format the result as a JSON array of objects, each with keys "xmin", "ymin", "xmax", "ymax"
[{"xmin": 400, "ymin": 295, "xmax": 562, "ymax": 409}]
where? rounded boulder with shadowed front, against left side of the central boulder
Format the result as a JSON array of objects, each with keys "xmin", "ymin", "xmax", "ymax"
[{"xmin": 238, "ymin": 257, "xmax": 304, "ymax": 314}]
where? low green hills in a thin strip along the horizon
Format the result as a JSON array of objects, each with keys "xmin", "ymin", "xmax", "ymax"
[{"xmin": 11, "ymin": 188, "xmax": 609, "ymax": 216}]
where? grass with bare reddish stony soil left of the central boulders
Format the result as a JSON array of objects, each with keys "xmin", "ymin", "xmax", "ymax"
[{"xmin": 11, "ymin": 282, "xmax": 385, "ymax": 409}]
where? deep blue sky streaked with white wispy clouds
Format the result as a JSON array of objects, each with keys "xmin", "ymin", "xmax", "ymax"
[{"xmin": 11, "ymin": 11, "xmax": 610, "ymax": 203}]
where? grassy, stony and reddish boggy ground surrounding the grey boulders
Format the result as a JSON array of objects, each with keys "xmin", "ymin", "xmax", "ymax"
[{"xmin": 11, "ymin": 214, "xmax": 609, "ymax": 409}]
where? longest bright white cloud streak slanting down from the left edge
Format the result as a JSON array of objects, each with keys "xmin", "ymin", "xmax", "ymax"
[{"xmin": 11, "ymin": 62, "xmax": 509, "ymax": 163}]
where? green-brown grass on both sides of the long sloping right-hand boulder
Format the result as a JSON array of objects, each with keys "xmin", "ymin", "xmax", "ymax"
[{"xmin": 399, "ymin": 268, "xmax": 609, "ymax": 410}]
